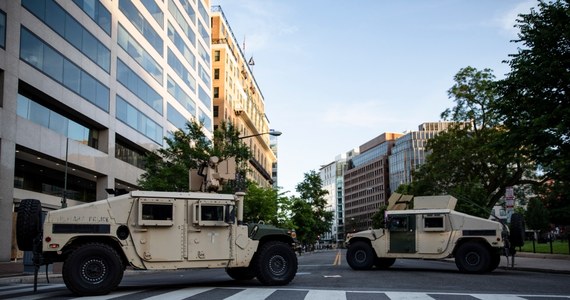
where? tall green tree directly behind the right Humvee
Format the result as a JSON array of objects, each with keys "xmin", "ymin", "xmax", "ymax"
[{"xmin": 412, "ymin": 67, "xmax": 535, "ymax": 217}]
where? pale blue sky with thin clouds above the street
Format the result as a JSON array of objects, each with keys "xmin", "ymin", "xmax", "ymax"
[{"xmin": 206, "ymin": 0, "xmax": 538, "ymax": 195}]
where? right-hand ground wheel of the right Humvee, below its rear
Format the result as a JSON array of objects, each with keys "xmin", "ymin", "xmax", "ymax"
[{"xmin": 455, "ymin": 242, "xmax": 491, "ymax": 273}]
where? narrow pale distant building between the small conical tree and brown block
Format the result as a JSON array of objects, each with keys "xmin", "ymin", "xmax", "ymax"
[{"xmin": 319, "ymin": 148, "xmax": 359, "ymax": 245}]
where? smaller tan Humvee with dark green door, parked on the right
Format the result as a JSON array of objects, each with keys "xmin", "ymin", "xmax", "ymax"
[{"xmin": 346, "ymin": 193, "xmax": 524, "ymax": 273}]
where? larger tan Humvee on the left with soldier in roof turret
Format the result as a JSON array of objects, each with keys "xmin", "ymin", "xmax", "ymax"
[{"xmin": 16, "ymin": 158, "xmax": 297, "ymax": 295}]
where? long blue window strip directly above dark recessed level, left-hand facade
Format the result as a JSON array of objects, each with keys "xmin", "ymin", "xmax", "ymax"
[{"xmin": 20, "ymin": 26, "xmax": 109, "ymax": 112}]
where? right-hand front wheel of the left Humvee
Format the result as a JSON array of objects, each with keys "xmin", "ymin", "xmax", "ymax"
[{"xmin": 251, "ymin": 241, "xmax": 298, "ymax": 285}]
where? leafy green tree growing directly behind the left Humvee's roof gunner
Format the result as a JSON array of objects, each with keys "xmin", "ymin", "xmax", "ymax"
[{"xmin": 138, "ymin": 121, "xmax": 251, "ymax": 192}]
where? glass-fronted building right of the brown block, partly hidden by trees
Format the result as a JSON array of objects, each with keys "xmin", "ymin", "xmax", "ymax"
[{"xmin": 388, "ymin": 122, "xmax": 457, "ymax": 192}]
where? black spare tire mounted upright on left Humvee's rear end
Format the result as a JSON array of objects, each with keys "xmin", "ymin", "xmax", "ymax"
[{"xmin": 16, "ymin": 199, "xmax": 43, "ymax": 251}]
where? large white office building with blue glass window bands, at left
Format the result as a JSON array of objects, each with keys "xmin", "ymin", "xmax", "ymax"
[{"xmin": 0, "ymin": 0, "xmax": 212, "ymax": 261}]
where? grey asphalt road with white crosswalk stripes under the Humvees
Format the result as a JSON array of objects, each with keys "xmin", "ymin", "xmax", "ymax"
[{"xmin": 0, "ymin": 251, "xmax": 570, "ymax": 300}]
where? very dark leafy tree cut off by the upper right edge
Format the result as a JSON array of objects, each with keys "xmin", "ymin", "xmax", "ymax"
[{"xmin": 498, "ymin": 0, "xmax": 570, "ymax": 185}]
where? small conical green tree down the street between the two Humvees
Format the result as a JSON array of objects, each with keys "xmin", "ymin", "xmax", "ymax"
[{"xmin": 292, "ymin": 170, "xmax": 333, "ymax": 244}]
